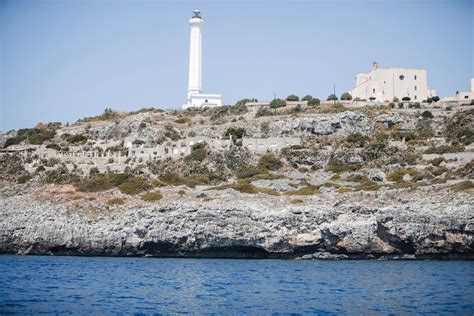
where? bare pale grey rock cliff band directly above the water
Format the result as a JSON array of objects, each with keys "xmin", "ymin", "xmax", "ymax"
[{"xmin": 0, "ymin": 185, "xmax": 474, "ymax": 259}]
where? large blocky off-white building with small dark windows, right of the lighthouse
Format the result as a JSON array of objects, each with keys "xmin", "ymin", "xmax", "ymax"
[{"xmin": 351, "ymin": 63, "xmax": 436, "ymax": 102}]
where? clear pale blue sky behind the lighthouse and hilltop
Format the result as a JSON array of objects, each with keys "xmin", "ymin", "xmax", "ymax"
[{"xmin": 0, "ymin": 0, "xmax": 474, "ymax": 131}]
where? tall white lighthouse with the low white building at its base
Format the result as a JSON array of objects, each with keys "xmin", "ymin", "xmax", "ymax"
[{"xmin": 183, "ymin": 10, "xmax": 222, "ymax": 109}]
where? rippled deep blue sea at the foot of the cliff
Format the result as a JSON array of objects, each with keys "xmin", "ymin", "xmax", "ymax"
[{"xmin": 0, "ymin": 256, "xmax": 474, "ymax": 314}]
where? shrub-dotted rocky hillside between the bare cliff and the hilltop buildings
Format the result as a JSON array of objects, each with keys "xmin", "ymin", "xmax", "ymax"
[{"xmin": 0, "ymin": 99, "xmax": 474, "ymax": 206}]
